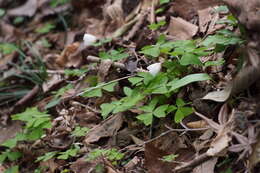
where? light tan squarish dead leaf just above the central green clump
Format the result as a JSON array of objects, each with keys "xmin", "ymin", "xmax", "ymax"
[{"xmin": 168, "ymin": 17, "xmax": 198, "ymax": 40}]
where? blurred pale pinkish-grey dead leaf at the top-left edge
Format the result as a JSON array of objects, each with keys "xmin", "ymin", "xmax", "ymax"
[{"xmin": 7, "ymin": 0, "xmax": 38, "ymax": 17}]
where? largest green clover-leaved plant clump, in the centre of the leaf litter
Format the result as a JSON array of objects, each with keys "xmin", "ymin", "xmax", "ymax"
[{"xmin": 80, "ymin": 30, "xmax": 243, "ymax": 126}]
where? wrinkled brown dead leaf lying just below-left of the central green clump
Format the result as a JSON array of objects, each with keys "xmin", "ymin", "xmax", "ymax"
[{"xmin": 84, "ymin": 113, "xmax": 123, "ymax": 144}]
